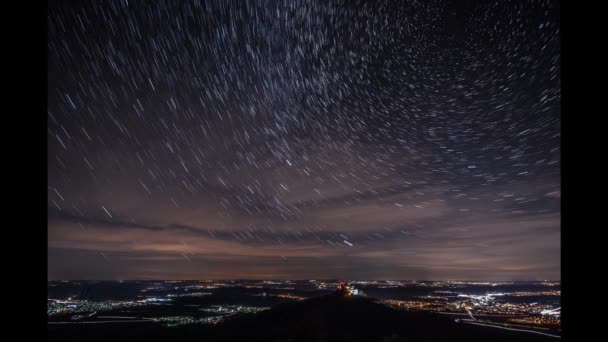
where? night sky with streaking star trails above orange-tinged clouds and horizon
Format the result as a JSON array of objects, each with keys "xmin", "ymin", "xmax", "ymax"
[{"xmin": 47, "ymin": 0, "xmax": 561, "ymax": 281}]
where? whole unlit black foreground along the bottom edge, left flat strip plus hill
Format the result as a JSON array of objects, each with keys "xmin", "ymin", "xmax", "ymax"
[{"xmin": 49, "ymin": 295, "xmax": 556, "ymax": 342}]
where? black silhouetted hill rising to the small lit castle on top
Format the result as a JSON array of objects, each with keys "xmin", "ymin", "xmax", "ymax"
[{"xmin": 208, "ymin": 295, "xmax": 555, "ymax": 342}]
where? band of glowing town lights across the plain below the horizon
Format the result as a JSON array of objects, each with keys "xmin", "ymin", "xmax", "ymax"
[{"xmin": 47, "ymin": 280, "xmax": 561, "ymax": 334}]
